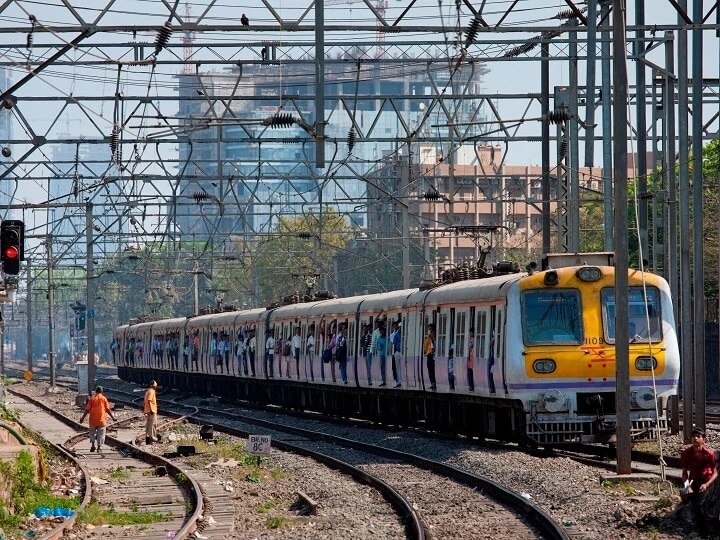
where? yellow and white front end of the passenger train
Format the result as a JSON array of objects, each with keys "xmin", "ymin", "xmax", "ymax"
[{"xmin": 506, "ymin": 265, "xmax": 680, "ymax": 444}]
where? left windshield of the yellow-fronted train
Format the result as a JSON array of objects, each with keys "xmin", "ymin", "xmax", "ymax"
[{"xmin": 522, "ymin": 289, "xmax": 583, "ymax": 345}]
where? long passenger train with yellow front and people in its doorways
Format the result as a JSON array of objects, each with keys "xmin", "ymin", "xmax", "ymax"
[{"xmin": 113, "ymin": 253, "xmax": 680, "ymax": 446}]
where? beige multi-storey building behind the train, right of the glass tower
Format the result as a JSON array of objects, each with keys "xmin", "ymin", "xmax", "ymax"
[{"xmin": 368, "ymin": 146, "xmax": 603, "ymax": 271}]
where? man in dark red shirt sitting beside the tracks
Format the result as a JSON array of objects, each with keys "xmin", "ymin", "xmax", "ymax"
[{"xmin": 680, "ymin": 427, "xmax": 718, "ymax": 529}]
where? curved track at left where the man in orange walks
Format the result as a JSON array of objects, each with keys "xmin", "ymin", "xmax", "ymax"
[{"xmin": 7, "ymin": 387, "xmax": 204, "ymax": 539}]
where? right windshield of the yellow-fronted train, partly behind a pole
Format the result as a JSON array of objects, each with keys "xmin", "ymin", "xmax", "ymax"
[{"xmin": 601, "ymin": 287, "xmax": 662, "ymax": 343}]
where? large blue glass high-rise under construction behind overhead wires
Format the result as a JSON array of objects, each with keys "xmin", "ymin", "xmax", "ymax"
[{"xmin": 176, "ymin": 61, "xmax": 485, "ymax": 242}]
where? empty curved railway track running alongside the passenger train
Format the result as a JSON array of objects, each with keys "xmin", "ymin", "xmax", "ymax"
[{"xmin": 94, "ymin": 380, "xmax": 568, "ymax": 538}]
